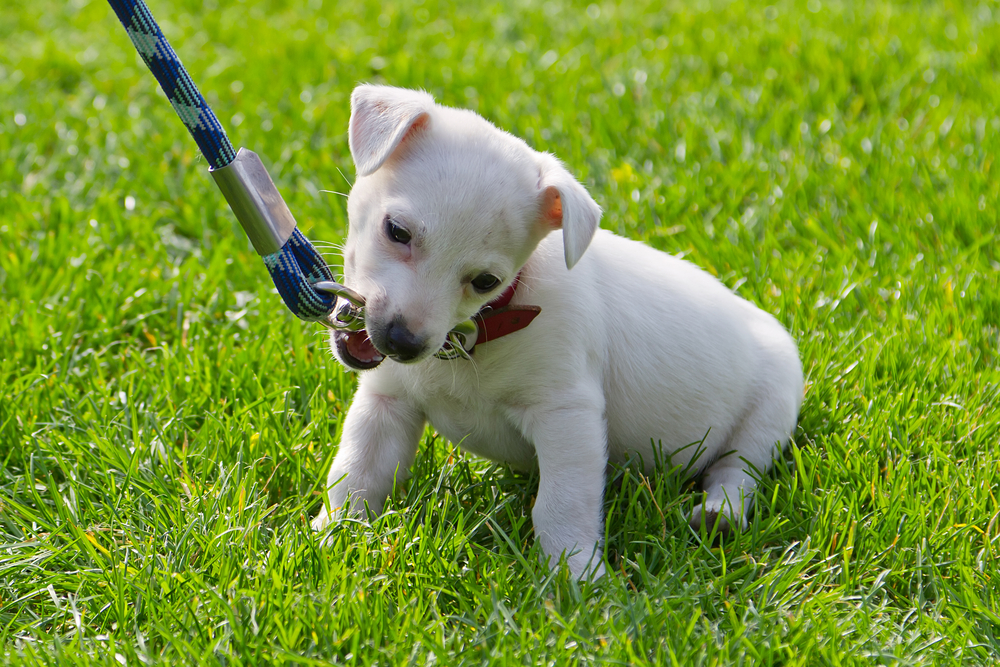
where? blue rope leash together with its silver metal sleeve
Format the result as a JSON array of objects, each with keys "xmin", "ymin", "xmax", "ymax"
[{"xmin": 108, "ymin": 0, "xmax": 337, "ymax": 321}]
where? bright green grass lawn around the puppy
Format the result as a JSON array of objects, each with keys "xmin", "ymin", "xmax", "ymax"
[{"xmin": 0, "ymin": 0, "xmax": 1000, "ymax": 665}]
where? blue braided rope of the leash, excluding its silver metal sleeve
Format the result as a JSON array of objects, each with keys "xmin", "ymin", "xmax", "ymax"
[{"xmin": 108, "ymin": 0, "xmax": 337, "ymax": 321}]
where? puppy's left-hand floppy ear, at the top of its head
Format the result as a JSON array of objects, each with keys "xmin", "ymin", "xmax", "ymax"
[{"xmin": 348, "ymin": 84, "xmax": 434, "ymax": 176}]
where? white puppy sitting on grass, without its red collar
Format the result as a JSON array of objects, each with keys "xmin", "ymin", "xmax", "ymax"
[{"xmin": 313, "ymin": 85, "xmax": 803, "ymax": 577}]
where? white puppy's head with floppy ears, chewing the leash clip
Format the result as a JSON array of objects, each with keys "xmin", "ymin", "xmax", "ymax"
[{"xmin": 334, "ymin": 85, "xmax": 601, "ymax": 369}]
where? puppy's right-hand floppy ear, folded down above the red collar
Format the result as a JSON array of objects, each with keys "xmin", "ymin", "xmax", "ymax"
[{"xmin": 538, "ymin": 153, "xmax": 601, "ymax": 269}]
